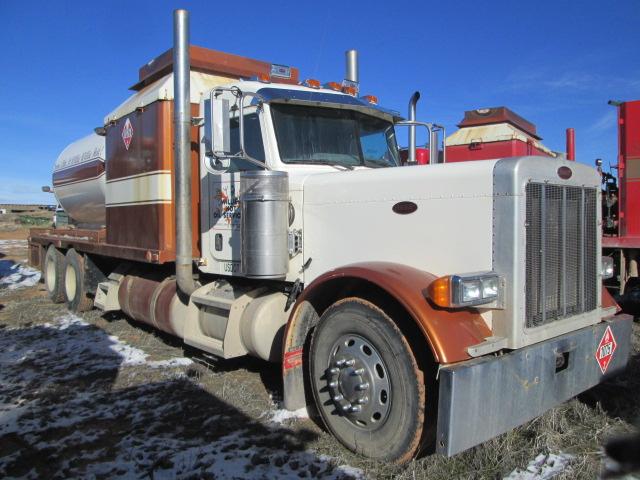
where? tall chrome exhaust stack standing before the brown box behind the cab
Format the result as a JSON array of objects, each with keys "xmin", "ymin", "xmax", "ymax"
[{"xmin": 173, "ymin": 10, "xmax": 196, "ymax": 295}]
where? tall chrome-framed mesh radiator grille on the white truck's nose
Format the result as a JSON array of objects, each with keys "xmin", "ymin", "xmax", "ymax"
[{"xmin": 525, "ymin": 183, "xmax": 598, "ymax": 328}]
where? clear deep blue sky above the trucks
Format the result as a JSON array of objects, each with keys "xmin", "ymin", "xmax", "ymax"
[{"xmin": 0, "ymin": 0, "xmax": 640, "ymax": 203}]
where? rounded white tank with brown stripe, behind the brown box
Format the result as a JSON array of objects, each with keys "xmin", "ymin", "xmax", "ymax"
[{"xmin": 53, "ymin": 133, "xmax": 106, "ymax": 228}]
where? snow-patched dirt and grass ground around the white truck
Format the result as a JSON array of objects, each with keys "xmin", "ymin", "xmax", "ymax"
[{"xmin": 0, "ymin": 234, "xmax": 640, "ymax": 480}]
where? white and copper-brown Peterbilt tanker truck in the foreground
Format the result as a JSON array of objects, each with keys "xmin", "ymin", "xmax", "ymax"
[{"xmin": 29, "ymin": 10, "xmax": 631, "ymax": 462}]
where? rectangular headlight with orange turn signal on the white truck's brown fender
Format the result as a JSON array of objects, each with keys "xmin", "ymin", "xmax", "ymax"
[{"xmin": 427, "ymin": 272, "xmax": 502, "ymax": 308}]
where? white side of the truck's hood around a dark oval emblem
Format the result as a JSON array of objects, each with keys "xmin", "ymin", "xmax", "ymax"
[{"xmin": 300, "ymin": 160, "xmax": 497, "ymax": 283}]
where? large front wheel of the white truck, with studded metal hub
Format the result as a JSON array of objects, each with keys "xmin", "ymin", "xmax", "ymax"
[{"xmin": 310, "ymin": 298, "xmax": 425, "ymax": 463}]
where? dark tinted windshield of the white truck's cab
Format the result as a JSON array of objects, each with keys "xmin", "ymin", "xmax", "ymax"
[{"xmin": 271, "ymin": 104, "xmax": 399, "ymax": 168}]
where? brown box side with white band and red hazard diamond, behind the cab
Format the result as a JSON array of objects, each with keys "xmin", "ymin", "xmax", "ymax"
[{"xmin": 105, "ymin": 101, "xmax": 200, "ymax": 258}]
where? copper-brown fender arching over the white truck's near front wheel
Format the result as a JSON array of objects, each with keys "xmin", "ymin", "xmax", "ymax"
[{"xmin": 282, "ymin": 262, "xmax": 491, "ymax": 410}]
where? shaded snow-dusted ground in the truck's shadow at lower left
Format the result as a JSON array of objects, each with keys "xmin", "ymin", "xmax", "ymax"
[{"xmin": 0, "ymin": 314, "xmax": 363, "ymax": 479}]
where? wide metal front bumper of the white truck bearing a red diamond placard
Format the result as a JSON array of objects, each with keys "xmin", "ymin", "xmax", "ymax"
[{"xmin": 436, "ymin": 315, "xmax": 633, "ymax": 456}]
